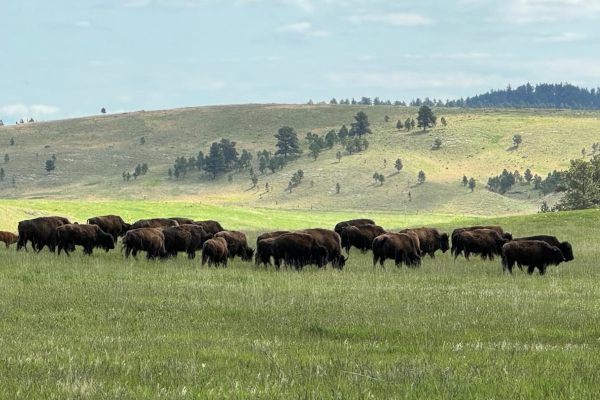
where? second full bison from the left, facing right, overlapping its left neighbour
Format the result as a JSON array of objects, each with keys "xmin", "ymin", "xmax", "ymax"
[{"xmin": 56, "ymin": 224, "xmax": 115, "ymax": 256}]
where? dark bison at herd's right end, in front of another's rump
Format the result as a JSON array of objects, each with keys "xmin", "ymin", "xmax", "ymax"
[{"xmin": 502, "ymin": 240, "xmax": 565, "ymax": 275}]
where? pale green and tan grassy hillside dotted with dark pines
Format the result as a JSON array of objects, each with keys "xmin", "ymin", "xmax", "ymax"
[{"xmin": 0, "ymin": 105, "xmax": 600, "ymax": 215}]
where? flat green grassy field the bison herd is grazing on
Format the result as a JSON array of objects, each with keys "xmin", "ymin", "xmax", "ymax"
[{"xmin": 0, "ymin": 201, "xmax": 600, "ymax": 399}]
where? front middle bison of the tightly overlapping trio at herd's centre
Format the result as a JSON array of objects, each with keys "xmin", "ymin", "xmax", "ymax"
[{"xmin": 270, "ymin": 232, "xmax": 328, "ymax": 271}]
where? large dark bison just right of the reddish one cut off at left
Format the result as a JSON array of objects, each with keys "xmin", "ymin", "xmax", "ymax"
[{"xmin": 17, "ymin": 217, "xmax": 71, "ymax": 253}]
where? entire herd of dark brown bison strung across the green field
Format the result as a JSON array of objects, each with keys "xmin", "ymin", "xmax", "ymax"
[{"xmin": 0, "ymin": 215, "xmax": 573, "ymax": 275}]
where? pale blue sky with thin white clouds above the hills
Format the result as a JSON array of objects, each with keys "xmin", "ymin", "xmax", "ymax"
[{"xmin": 0, "ymin": 0, "xmax": 600, "ymax": 124}]
